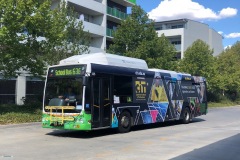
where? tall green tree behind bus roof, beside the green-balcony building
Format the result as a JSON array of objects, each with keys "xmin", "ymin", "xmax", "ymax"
[{"xmin": 109, "ymin": 5, "xmax": 157, "ymax": 55}]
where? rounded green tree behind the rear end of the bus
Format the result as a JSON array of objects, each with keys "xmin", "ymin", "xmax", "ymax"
[{"xmin": 180, "ymin": 40, "xmax": 219, "ymax": 91}]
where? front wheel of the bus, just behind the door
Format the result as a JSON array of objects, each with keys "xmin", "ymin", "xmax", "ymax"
[{"xmin": 118, "ymin": 111, "xmax": 131, "ymax": 133}]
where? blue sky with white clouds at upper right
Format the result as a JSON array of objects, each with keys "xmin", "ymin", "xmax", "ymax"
[{"xmin": 136, "ymin": 0, "xmax": 240, "ymax": 48}]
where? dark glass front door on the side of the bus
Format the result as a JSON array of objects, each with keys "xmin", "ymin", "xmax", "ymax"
[{"xmin": 92, "ymin": 78, "xmax": 111, "ymax": 128}]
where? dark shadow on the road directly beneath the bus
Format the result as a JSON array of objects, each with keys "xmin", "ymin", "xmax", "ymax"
[{"xmin": 46, "ymin": 118, "xmax": 205, "ymax": 139}]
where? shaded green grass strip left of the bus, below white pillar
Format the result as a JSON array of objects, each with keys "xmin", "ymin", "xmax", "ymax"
[{"xmin": 0, "ymin": 104, "xmax": 42, "ymax": 125}]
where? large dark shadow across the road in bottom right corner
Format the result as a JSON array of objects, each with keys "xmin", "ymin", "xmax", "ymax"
[{"xmin": 171, "ymin": 134, "xmax": 240, "ymax": 160}]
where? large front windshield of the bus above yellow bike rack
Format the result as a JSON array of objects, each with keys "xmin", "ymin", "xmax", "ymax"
[{"xmin": 44, "ymin": 77, "xmax": 83, "ymax": 111}]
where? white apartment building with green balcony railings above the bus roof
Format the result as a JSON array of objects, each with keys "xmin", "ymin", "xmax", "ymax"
[{"xmin": 52, "ymin": 0, "xmax": 136, "ymax": 53}]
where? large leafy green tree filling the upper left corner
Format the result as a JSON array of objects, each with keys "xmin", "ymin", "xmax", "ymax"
[{"xmin": 0, "ymin": 0, "xmax": 90, "ymax": 77}]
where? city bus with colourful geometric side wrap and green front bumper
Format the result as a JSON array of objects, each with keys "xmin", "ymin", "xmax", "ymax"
[{"xmin": 42, "ymin": 53, "xmax": 208, "ymax": 133}]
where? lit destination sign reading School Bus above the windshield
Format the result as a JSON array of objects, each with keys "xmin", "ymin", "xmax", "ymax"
[{"xmin": 48, "ymin": 65, "xmax": 86, "ymax": 77}]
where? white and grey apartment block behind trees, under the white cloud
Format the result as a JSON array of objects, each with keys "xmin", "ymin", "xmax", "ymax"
[{"xmin": 155, "ymin": 19, "xmax": 224, "ymax": 58}]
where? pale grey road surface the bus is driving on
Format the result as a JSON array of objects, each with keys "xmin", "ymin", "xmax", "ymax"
[{"xmin": 0, "ymin": 106, "xmax": 240, "ymax": 160}]
